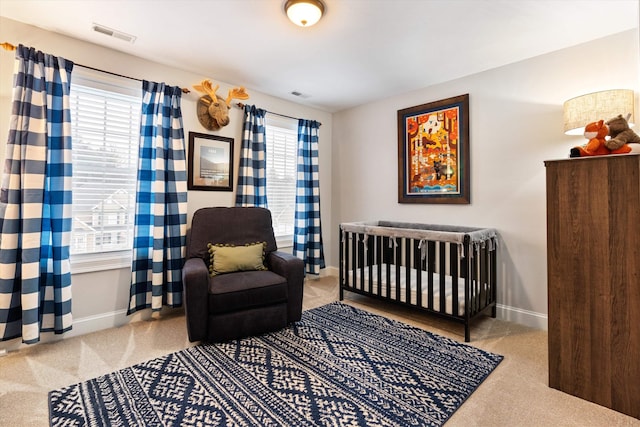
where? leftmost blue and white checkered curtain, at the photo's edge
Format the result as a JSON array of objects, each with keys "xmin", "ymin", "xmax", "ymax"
[{"xmin": 0, "ymin": 45, "xmax": 73, "ymax": 344}]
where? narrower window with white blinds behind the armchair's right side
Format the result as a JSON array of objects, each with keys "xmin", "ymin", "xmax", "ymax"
[{"xmin": 265, "ymin": 114, "xmax": 298, "ymax": 247}]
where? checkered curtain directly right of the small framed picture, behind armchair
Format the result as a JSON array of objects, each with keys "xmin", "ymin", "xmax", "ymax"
[{"xmin": 236, "ymin": 105, "xmax": 267, "ymax": 208}]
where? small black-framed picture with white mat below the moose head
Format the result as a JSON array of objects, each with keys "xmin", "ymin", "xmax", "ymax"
[{"xmin": 187, "ymin": 132, "xmax": 233, "ymax": 191}]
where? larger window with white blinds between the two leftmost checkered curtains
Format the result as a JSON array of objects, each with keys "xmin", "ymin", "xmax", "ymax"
[{"xmin": 70, "ymin": 70, "xmax": 142, "ymax": 271}]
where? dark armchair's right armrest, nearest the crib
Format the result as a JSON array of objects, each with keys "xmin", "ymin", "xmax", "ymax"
[{"xmin": 267, "ymin": 251, "xmax": 304, "ymax": 322}]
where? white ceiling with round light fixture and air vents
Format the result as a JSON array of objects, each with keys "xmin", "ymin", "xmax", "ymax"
[{"xmin": 0, "ymin": 0, "xmax": 639, "ymax": 112}]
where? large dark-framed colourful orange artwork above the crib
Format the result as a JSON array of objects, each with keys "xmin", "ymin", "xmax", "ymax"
[{"xmin": 398, "ymin": 94, "xmax": 470, "ymax": 204}]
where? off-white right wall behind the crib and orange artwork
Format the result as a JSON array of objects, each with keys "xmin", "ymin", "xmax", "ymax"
[{"xmin": 330, "ymin": 30, "xmax": 640, "ymax": 328}]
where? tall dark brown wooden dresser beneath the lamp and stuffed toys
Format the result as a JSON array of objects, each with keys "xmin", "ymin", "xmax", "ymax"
[{"xmin": 545, "ymin": 154, "xmax": 640, "ymax": 419}]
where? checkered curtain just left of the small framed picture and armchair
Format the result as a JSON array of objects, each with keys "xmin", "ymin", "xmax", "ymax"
[{"xmin": 127, "ymin": 81, "xmax": 187, "ymax": 314}]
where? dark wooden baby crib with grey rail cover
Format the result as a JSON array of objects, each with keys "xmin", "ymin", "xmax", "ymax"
[{"xmin": 339, "ymin": 221, "xmax": 496, "ymax": 342}]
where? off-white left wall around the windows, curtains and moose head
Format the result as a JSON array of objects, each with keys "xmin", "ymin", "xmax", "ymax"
[{"xmin": 0, "ymin": 17, "xmax": 334, "ymax": 349}]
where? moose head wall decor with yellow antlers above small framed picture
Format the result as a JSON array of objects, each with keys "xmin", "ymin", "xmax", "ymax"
[{"xmin": 193, "ymin": 79, "xmax": 249, "ymax": 130}]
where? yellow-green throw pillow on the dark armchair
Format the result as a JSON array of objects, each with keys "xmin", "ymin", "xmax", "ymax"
[{"xmin": 207, "ymin": 242, "xmax": 267, "ymax": 277}]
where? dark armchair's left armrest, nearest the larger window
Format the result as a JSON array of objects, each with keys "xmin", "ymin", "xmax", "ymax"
[{"xmin": 182, "ymin": 258, "xmax": 209, "ymax": 342}]
